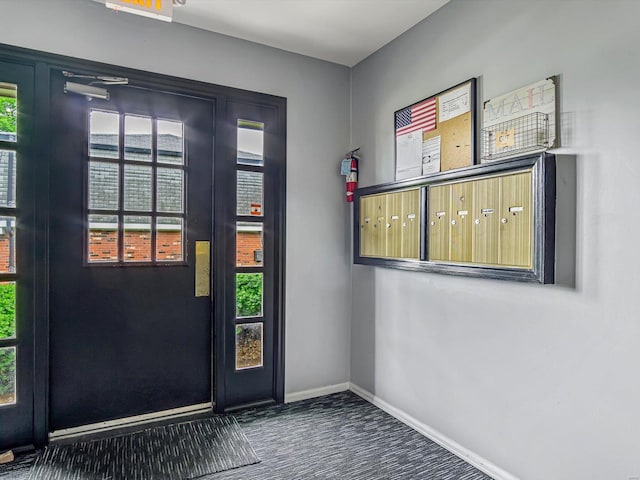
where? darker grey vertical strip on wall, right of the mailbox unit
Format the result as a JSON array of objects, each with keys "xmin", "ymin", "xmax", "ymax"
[{"xmin": 555, "ymin": 155, "xmax": 577, "ymax": 289}]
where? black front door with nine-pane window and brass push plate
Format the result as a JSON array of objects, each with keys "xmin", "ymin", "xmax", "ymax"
[{"xmin": 50, "ymin": 73, "xmax": 214, "ymax": 431}]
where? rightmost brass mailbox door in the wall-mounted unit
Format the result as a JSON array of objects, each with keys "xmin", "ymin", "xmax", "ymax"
[{"xmin": 499, "ymin": 171, "xmax": 533, "ymax": 268}]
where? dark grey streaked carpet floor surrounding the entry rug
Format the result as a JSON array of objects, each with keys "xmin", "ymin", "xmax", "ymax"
[{"xmin": 0, "ymin": 392, "xmax": 490, "ymax": 480}]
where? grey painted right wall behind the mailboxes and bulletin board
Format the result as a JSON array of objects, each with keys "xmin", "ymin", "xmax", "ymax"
[{"xmin": 351, "ymin": 0, "xmax": 640, "ymax": 480}]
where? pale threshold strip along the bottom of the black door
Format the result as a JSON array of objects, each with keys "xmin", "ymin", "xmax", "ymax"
[{"xmin": 49, "ymin": 402, "xmax": 213, "ymax": 440}]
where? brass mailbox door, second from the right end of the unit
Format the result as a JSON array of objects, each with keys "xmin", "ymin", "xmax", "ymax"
[{"xmin": 472, "ymin": 177, "xmax": 500, "ymax": 265}]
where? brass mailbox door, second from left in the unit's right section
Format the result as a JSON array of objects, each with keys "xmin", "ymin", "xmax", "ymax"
[{"xmin": 450, "ymin": 182, "xmax": 473, "ymax": 262}]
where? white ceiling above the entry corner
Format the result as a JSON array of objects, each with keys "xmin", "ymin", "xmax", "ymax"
[{"xmin": 101, "ymin": 0, "xmax": 449, "ymax": 67}]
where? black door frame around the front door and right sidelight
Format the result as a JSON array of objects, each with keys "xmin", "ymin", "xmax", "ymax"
[{"xmin": 0, "ymin": 44, "xmax": 287, "ymax": 446}]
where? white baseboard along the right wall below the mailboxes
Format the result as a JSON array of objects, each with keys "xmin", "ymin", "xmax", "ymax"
[{"xmin": 349, "ymin": 383, "xmax": 518, "ymax": 480}]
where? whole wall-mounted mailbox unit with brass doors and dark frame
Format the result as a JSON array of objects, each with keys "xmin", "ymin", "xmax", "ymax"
[{"xmin": 354, "ymin": 153, "xmax": 556, "ymax": 283}]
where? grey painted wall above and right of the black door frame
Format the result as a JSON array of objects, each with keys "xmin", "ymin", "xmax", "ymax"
[{"xmin": 0, "ymin": 0, "xmax": 350, "ymax": 393}]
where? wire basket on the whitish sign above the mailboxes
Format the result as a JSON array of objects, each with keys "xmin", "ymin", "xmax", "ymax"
[{"xmin": 482, "ymin": 112, "xmax": 549, "ymax": 162}]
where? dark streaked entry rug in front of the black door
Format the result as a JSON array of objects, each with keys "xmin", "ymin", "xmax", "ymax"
[{"xmin": 29, "ymin": 416, "xmax": 260, "ymax": 480}]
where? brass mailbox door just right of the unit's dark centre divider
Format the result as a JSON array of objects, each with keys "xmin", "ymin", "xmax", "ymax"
[{"xmin": 427, "ymin": 185, "xmax": 451, "ymax": 262}]
